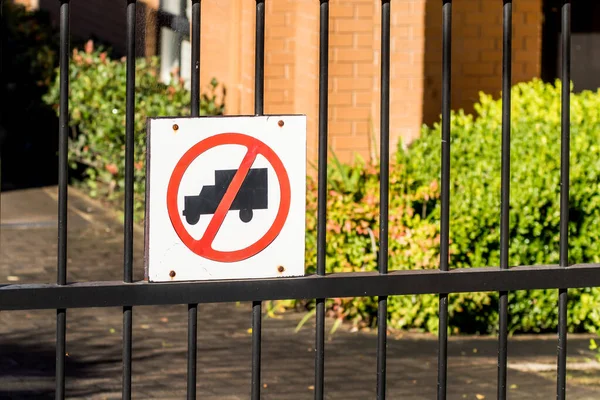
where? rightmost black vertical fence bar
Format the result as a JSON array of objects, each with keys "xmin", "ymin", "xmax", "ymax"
[{"xmin": 556, "ymin": 0, "xmax": 571, "ymax": 400}]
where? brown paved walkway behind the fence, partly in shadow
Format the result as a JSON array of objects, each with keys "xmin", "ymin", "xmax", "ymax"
[{"xmin": 0, "ymin": 188, "xmax": 600, "ymax": 400}]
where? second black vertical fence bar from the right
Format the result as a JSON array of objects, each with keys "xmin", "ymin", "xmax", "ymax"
[{"xmin": 498, "ymin": 0, "xmax": 512, "ymax": 400}]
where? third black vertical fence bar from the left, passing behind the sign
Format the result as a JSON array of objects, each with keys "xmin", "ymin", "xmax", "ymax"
[{"xmin": 183, "ymin": 0, "xmax": 201, "ymax": 400}]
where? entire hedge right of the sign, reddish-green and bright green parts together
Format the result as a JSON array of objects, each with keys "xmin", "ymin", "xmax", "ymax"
[{"xmin": 274, "ymin": 80, "xmax": 600, "ymax": 333}]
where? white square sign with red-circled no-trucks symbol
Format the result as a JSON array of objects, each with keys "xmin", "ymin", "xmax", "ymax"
[{"xmin": 146, "ymin": 115, "xmax": 306, "ymax": 282}]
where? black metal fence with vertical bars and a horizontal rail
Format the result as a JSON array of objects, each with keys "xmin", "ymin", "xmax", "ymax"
[{"xmin": 0, "ymin": 0, "xmax": 600, "ymax": 399}]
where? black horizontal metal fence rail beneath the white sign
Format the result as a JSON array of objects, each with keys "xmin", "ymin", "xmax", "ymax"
[{"xmin": 0, "ymin": 264, "xmax": 600, "ymax": 310}]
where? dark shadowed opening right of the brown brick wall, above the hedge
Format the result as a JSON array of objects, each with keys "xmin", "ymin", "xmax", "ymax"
[{"xmin": 542, "ymin": 0, "xmax": 600, "ymax": 92}]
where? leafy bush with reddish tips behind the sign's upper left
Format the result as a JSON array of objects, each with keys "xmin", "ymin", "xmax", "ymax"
[{"xmin": 44, "ymin": 42, "xmax": 225, "ymax": 216}]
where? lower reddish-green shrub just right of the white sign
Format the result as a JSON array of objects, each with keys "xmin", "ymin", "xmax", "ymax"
[{"xmin": 270, "ymin": 158, "xmax": 439, "ymax": 331}]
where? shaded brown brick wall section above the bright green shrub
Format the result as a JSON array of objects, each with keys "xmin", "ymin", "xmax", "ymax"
[{"xmin": 423, "ymin": 0, "xmax": 542, "ymax": 123}]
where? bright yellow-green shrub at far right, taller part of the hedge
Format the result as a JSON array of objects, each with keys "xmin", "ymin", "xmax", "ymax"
[{"xmin": 397, "ymin": 80, "xmax": 600, "ymax": 332}]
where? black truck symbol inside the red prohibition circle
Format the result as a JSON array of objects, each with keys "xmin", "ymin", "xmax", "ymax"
[{"xmin": 183, "ymin": 168, "xmax": 268, "ymax": 225}]
